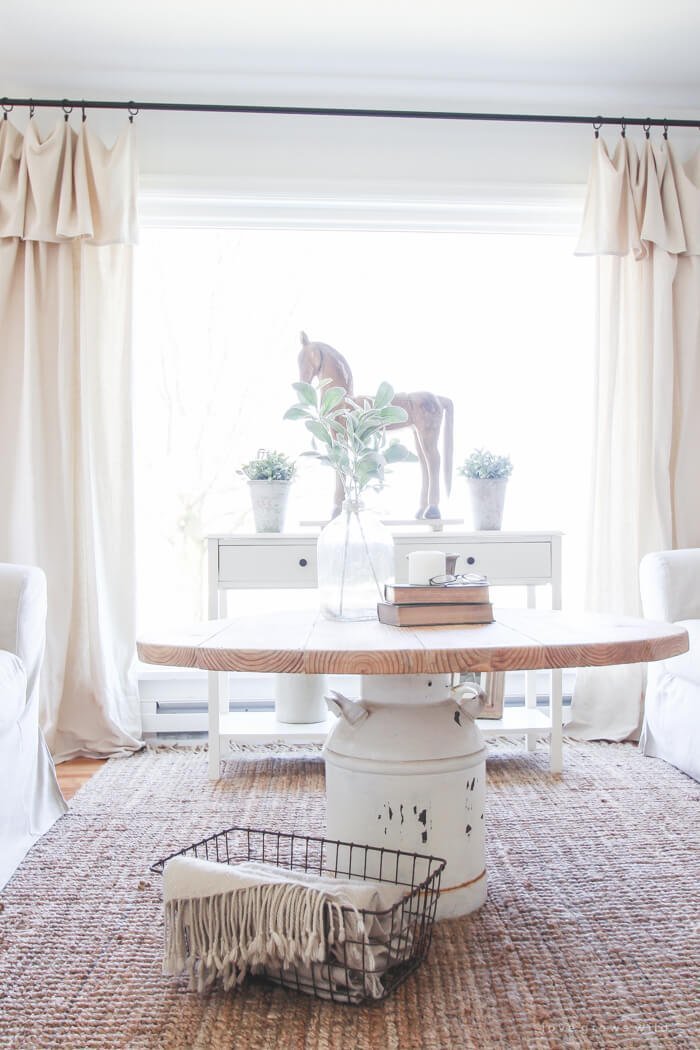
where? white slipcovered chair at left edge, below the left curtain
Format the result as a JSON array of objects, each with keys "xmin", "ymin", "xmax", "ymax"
[{"xmin": 0, "ymin": 564, "xmax": 67, "ymax": 888}]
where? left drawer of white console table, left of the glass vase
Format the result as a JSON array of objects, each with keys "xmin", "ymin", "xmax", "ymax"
[{"xmin": 218, "ymin": 540, "xmax": 316, "ymax": 588}]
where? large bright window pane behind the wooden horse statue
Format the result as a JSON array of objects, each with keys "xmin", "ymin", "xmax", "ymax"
[{"xmin": 134, "ymin": 221, "xmax": 595, "ymax": 626}]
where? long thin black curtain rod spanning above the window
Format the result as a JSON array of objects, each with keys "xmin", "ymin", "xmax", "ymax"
[{"xmin": 0, "ymin": 98, "xmax": 700, "ymax": 129}]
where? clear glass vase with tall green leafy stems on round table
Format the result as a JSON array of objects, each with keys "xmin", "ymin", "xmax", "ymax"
[{"xmin": 284, "ymin": 380, "xmax": 416, "ymax": 620}]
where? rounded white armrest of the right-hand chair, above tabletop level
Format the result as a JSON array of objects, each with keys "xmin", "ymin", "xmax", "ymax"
[{"xmin": 639, "ymin": 547, "xmax": 700, "ymax": 624}]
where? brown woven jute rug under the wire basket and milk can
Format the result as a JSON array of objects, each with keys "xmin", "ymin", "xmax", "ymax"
[{"xmin": 0, "ymin": 744, "xmax": 700, "ymax": 1050}]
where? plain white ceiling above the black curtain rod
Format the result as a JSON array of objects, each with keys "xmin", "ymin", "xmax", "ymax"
[{"xmin": 0, "ymin": 0, "xmax": 700, "ymax": 117}]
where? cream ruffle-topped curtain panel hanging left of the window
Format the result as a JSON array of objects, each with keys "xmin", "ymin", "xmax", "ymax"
[{"xmin": 0, "ymin": 120, "xmax": 141, "ymax": 760}]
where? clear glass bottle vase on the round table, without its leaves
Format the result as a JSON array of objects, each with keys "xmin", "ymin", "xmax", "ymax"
[{"xmin": 318, "ymin": 500, "xmax": 395, "ymax": 620}]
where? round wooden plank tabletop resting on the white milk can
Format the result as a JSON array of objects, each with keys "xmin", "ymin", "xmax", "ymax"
[{"xmin": 137, "ymin": 609, "xmax": 688, "ymax": 674}]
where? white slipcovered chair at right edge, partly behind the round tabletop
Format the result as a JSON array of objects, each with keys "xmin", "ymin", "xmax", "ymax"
[{"xmin": 639, "ymin": 548, "xmax": 700, "ymax": 780}]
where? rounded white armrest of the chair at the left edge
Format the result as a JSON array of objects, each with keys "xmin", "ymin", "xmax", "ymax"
[{"xmin": 0, "ymin": 564, "xmax": 46, "ymax": 700}]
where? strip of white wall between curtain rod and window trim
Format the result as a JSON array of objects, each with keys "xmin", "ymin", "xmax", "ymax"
[{"xmin": 131, "ymin": 113, "xmax": 592, "ymax": 187}]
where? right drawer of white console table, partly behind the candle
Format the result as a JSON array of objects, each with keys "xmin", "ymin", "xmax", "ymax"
[{"xmin": 397, "ymin": 540, "xmax": 552, "ymax": 584}]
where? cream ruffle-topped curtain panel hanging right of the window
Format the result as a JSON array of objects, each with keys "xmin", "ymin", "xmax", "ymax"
[{"xmin": 569, "ymin": 138, "xmax": 700, "ymax": 740}]
